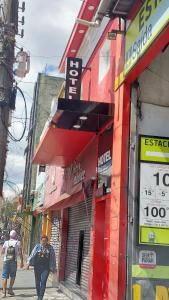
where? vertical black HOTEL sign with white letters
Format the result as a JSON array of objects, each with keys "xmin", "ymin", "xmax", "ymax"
[{"xmin": 65, "ymin": 57, "xmax": 82, "ymax": 100}]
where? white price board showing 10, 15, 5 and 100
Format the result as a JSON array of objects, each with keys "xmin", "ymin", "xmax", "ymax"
[{"xmin": 140, "ymin": 163, "xmax": 169, "ymax": 227}]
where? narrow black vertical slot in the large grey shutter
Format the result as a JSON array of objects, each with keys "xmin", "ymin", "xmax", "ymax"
[{"xmin": 76, "ymin": 230, "xmax": 84, "ymax": 285}]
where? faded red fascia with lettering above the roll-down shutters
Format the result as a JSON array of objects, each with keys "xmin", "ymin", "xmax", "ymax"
[{"xmin": 44, "ymin": 138, "xmax": 97, "ymax": 209}]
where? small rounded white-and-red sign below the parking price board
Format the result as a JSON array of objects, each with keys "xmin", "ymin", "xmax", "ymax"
[{"xmin": 139, "ymin": 250, "xmax": 156, "ymax": 269}]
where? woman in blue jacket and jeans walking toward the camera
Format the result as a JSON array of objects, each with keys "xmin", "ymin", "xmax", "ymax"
[{"xmin": 27, "ymin": 235, "xmax": 56, "ymax": 300}]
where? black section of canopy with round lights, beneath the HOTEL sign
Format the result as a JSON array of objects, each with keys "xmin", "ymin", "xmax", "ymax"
[{"xmin": 52, "ymin": 98, "xmax": 114, "ymax": 132}]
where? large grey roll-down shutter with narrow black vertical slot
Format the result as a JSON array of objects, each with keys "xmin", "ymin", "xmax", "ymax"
[{"xmin": 65, "ymin": 197, "xmax": 92, "ymax": 294}]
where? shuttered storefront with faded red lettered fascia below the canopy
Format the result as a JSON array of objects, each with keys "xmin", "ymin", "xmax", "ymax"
[{"xmin": 44, "ymin": 138, "xmax": 98, "ymax": 297}]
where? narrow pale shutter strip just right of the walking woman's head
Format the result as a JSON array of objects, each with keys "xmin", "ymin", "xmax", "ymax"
[{"xmin": 50, "ymin": 214, "xmax": 60, "ymax": 268}]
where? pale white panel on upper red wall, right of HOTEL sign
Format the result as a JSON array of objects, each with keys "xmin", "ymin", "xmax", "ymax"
[{"xmin": 99, "ymin": 40, "xmax": 111, "ymax": 83}]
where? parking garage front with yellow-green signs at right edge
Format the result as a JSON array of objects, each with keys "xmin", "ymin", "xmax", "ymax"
[{"xmin": 115, "ymin": 1, "xmax": 169, "ymax": 300}]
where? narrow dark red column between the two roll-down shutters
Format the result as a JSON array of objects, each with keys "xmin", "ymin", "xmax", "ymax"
[{"xmin": 58, "ymin": 208, "xmax": 68, "ymax": 281}]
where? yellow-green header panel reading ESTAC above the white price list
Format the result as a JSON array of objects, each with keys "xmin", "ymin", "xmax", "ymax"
[{"xmin": 140, "ymin": 136, "xmax": 169, "ymax": 164}]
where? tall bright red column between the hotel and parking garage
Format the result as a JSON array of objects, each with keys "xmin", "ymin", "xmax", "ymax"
[{"xmin": 108, "ymin": 85, "xmax": 130, "ymax": 300}]
